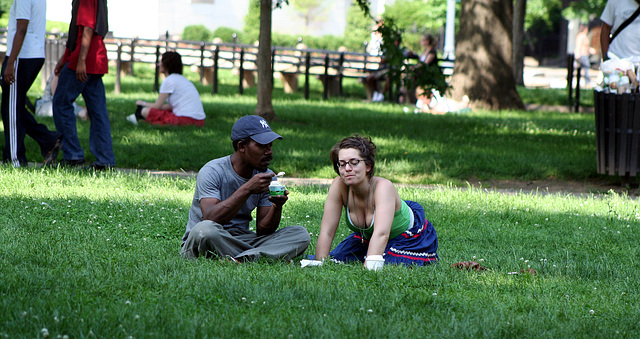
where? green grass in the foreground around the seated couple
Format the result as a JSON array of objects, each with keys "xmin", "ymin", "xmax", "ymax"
[{"xmin": 0, "ymin": 166, "xmax": 640, "ymax": 338}]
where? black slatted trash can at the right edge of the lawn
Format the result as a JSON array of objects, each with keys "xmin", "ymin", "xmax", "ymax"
[{"xmin": 593, "ymin": 91, "xmax": 640, "ymax": 177}]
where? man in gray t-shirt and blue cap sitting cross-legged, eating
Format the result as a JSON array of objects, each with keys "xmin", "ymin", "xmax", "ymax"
[{"xmin": 181, "ymin": 115, "xmax": 311, "ymax": 261}]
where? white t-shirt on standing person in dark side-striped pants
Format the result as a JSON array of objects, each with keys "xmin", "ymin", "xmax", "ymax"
[{"xmin": 7, "ymin": 0, "xmax": 47, "ymax": 59}]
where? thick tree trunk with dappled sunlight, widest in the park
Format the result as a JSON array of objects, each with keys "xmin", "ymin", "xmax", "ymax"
[{"xmin": 451, "ymin": 0, "xmax": 524, "ymax": 109}]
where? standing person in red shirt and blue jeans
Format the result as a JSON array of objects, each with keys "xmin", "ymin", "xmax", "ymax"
[{"xmin": 53, "ymin": 0, "xmax": 116, "ymax": 170}]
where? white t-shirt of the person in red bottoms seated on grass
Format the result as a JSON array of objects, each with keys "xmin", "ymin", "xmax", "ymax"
[{"xmin": 160, "ymin": 73, "xmax": 206, "ymax": 120}]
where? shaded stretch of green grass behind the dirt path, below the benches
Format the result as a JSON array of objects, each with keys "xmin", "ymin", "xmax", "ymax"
[{"xmin": 16, "ymin": 65, "xmax": 597, "ymax": 185}]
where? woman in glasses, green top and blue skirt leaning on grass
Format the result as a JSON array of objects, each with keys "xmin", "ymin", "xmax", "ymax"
[{"xmin": 308, "ymin": 135, "xmax": 438, "ymax": 269}]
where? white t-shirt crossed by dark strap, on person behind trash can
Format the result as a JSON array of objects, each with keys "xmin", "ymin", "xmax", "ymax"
[{"xmin": 600, "ymin": 0, "xmax": 640, "ymax": 58}]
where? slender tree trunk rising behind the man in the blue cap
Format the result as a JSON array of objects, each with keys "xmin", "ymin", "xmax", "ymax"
[{"xmin": 254, "ymin": 0, "xmax": 277, "ymax": 122}]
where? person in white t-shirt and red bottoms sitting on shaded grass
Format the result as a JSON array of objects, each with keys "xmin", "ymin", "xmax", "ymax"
[{"xmin": 127, "ymin": 51, "xmax": 205, "ymax": 127}]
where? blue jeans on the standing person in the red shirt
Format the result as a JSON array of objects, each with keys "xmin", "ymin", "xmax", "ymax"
[{"xmin": 53, "ymin": 65, "xmax": 116, "ymax": 166}]
